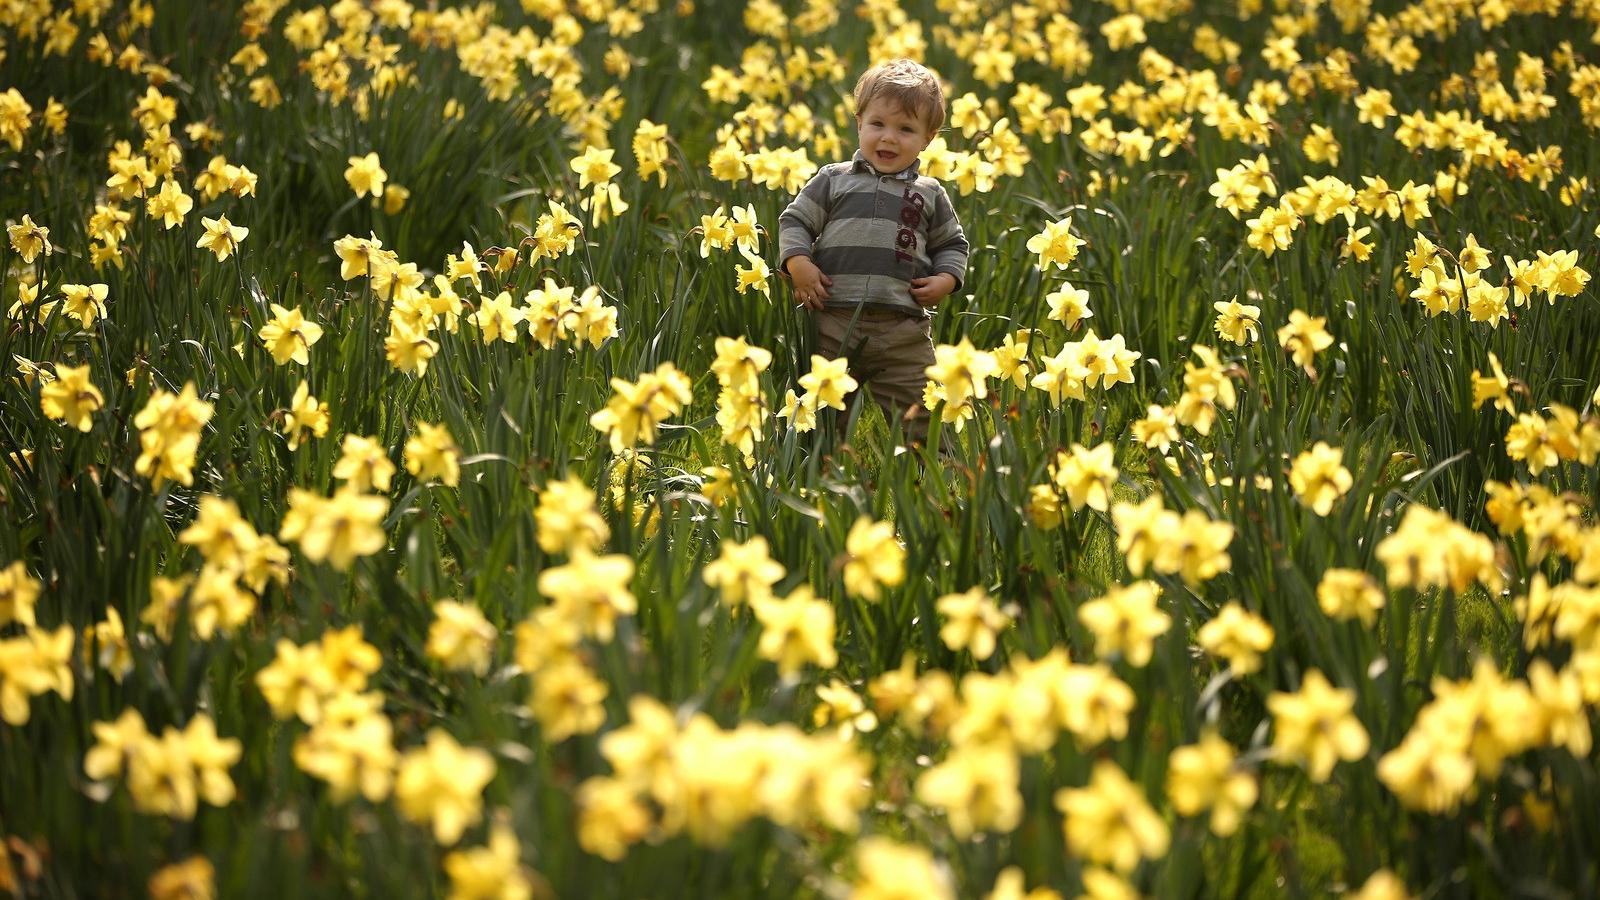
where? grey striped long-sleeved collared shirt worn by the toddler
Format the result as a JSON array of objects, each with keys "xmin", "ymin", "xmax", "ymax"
[{"xmin": 778, "ymin": 151, "xmax": 968, "ymax": 315}]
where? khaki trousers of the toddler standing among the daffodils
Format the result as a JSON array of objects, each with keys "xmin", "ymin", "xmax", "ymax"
[{"xmin": 813, "ymin": 307, "xmax": 933, "ymax": 444}]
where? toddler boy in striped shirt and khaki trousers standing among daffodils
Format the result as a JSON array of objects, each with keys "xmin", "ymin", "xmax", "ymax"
[{"xmin": 778, "ymin": 59, "xmax": 968, "ymax": 444}]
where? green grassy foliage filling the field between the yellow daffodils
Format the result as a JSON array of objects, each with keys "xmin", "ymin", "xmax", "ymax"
[{"xmin": 0, "ymin": 0, "xmax": 1600, "ymax": 897}]
